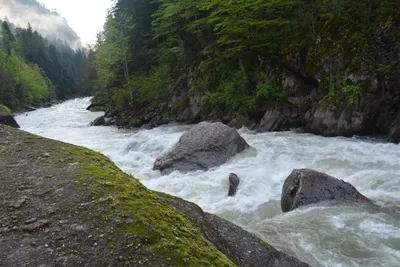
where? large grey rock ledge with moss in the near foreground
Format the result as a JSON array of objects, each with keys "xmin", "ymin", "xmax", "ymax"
[{"xmin": 0, "ymin": 125, "xmax": 308, "ymax": 266}]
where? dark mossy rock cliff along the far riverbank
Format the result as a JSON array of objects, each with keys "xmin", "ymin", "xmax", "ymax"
[{"xmin": 97, "ymin": 6, "xmax": 400, "ymax": 143}]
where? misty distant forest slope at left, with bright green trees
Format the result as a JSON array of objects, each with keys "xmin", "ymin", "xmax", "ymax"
[{"xmin": 0, "ymin": 20, "xmax": 95, "ymax": 110}]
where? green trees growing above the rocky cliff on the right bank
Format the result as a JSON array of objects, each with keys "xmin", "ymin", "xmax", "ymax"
[{"xmin": 95, "ymin": 0, "xmax": 400, "ymax": 126}]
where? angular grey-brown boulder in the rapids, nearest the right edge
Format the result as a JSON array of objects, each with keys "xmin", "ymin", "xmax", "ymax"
[{"xmin": 281, "ymin": 169, "xmax": 374, "ymax": 212}]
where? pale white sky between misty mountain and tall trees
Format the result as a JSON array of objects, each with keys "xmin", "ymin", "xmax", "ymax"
[{"xmin": 39, "ymin": 0, "xmax": 113, "ymax": 45}]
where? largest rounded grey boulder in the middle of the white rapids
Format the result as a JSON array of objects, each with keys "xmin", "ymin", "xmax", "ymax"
[{"xmin": 153, "ymin": 122, "xmax": 249, "ymax": 174}]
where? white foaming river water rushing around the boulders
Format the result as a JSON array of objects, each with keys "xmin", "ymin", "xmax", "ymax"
[{"xmin": 16, "ymin": 98, "xmax": 400, "ymax": 266}]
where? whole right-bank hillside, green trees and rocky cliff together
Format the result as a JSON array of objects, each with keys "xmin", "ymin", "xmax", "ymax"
[{"xmin": 90, "ymin": 0, "xmax": 400, "ymax": 142}]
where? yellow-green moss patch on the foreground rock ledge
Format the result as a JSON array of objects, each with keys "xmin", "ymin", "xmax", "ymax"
[{"xmin": 58, "ymin": 145, "xmax": 234, "ymax": 266}]
